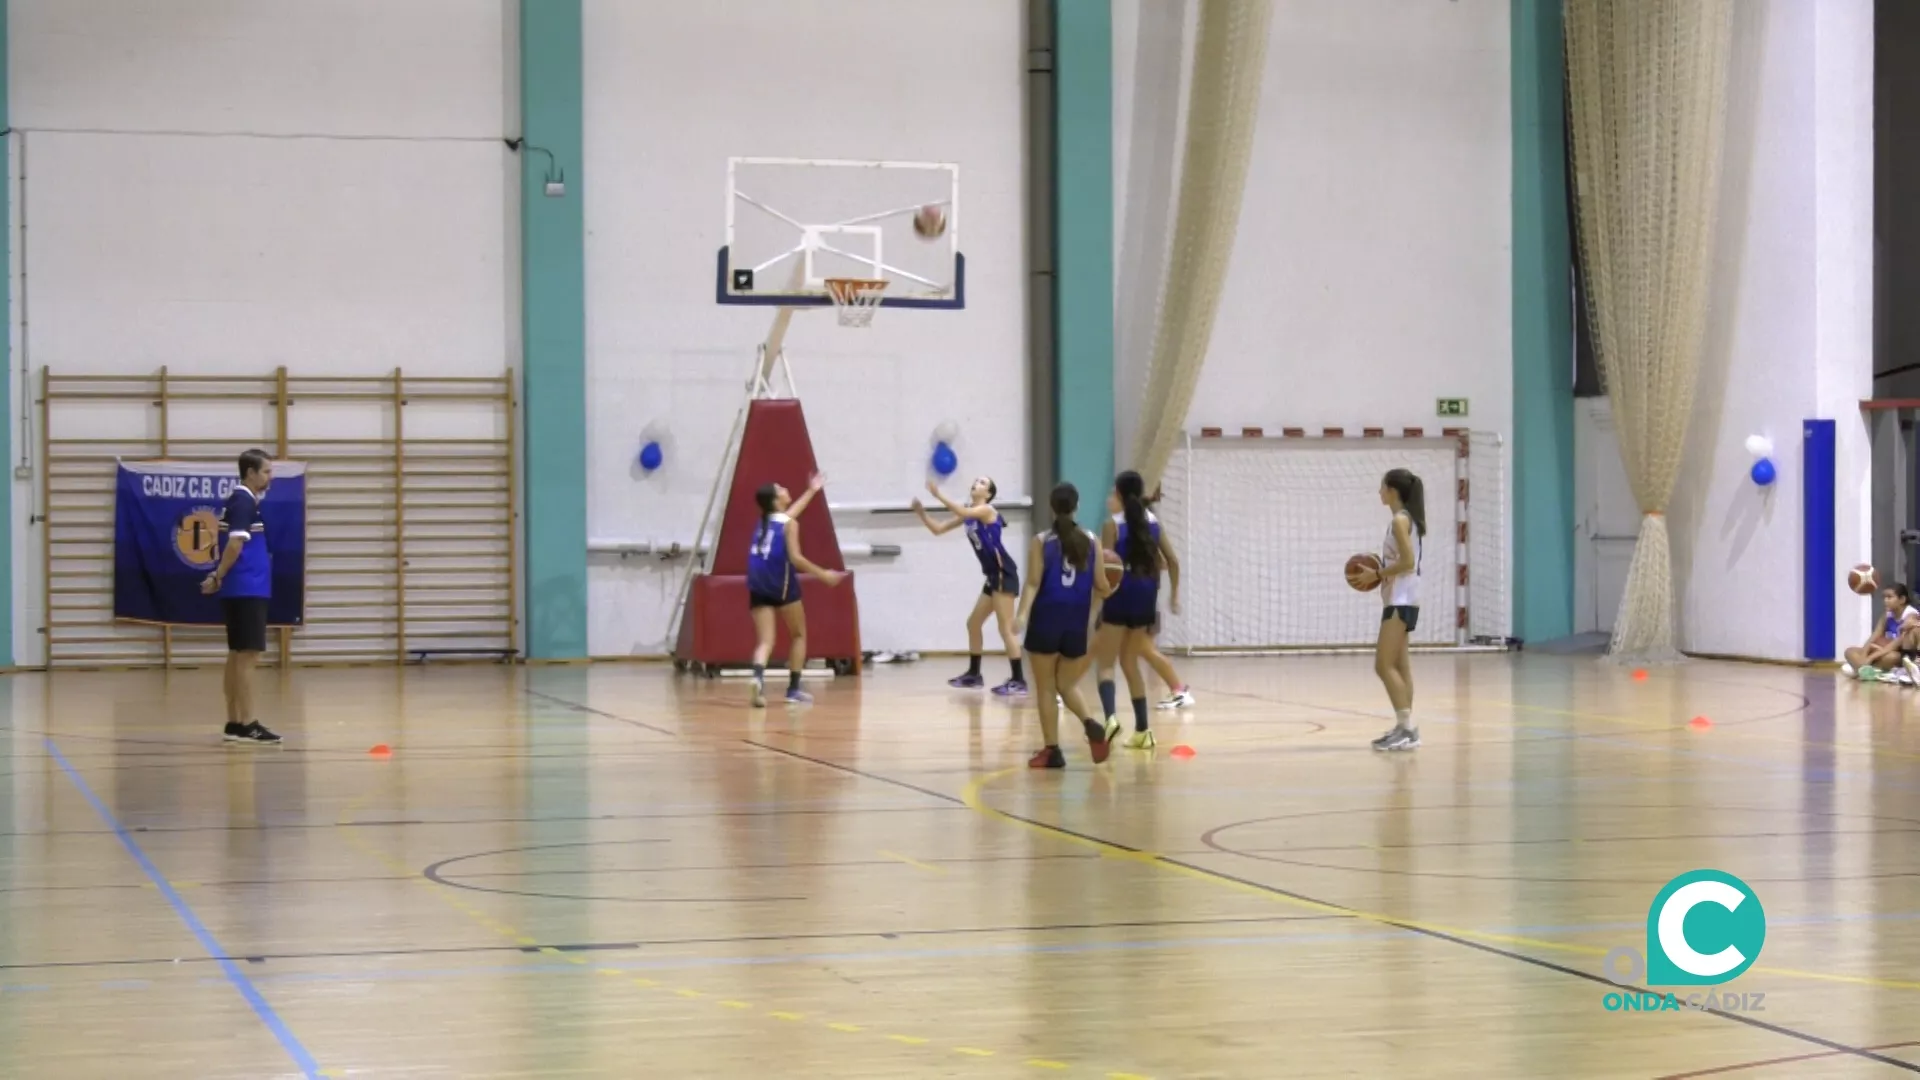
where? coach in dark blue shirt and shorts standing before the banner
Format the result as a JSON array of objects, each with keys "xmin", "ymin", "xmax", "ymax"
[{"xmin": 200, "ymin": 450, "xmax": 280, "ymax": 746}]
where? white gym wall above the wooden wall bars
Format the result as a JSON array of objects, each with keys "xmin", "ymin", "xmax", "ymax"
[{"xmin": 8, "ymin": 0, "xmax": 518, "ymax": 663}]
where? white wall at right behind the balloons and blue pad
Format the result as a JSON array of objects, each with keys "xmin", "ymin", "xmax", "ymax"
[{"xmin": 1668, "ymin": 0, "xmax": 1874, "ymax": 659}]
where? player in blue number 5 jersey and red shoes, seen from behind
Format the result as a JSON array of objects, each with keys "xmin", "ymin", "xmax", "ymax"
[{"xmin": 1014, "ymin": 484, "xmax": 1119, "ymax": 769}]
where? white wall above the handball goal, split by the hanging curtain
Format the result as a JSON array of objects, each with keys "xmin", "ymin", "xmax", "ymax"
[{"xmin": 1114, "ymin": 0, "xmax": 1513, "ymax": 638}]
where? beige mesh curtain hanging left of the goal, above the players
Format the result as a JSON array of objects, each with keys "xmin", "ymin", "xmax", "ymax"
[{"xmin": 1133, "ymin": 0, "xmax": 1273, "ymax": 490}]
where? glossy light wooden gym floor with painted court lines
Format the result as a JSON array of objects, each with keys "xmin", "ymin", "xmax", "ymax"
[{"xmin": 0, "ymin": 655, "xmax": 1920, "ymax": 1080}]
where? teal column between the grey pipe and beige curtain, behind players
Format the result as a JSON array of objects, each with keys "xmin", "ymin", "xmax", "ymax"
[{"xmin": 1059, "ymin": 0, "xmax": 1114, "ymax": 503}]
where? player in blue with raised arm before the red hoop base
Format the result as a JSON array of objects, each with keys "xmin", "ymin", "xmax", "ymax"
[{"xmin": 747, "ymin": 473, "xmax": 847, "ymax": 709}]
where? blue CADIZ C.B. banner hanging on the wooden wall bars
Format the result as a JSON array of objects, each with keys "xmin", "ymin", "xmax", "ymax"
[{"xmin": 113, "ymin": 461, "xmax": 307, "ymax": 626}]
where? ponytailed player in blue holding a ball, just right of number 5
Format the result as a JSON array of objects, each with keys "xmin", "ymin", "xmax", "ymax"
[{"xmin": 1094, "ymin": 469, "xmax": 1181, "ymax": 749}]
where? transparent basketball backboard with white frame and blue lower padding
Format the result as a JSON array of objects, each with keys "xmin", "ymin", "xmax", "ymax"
[{"xmin": 714, "ymin": 158, "xmax": 966, "ymax": 307}]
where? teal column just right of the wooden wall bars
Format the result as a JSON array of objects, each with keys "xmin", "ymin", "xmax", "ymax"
[{"xmin": 520, "ymin": 0, "xmax": 588, "ymax": 659}]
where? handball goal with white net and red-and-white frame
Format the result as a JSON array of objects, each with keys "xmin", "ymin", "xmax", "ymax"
[{"xmin": 1154, "ymin": 429, "xmax": 1509, "ymax": 651}]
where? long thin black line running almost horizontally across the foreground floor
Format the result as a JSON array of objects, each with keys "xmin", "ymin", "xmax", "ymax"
[{"xmin": 0, "ymin": 915, "xmax": 1346, "ymax": 970}]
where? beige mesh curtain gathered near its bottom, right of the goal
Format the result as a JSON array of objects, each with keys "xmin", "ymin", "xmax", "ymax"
[{"xmin": 1567, "ymin": 0, "xmax": 1732, "ymax": 663}]
